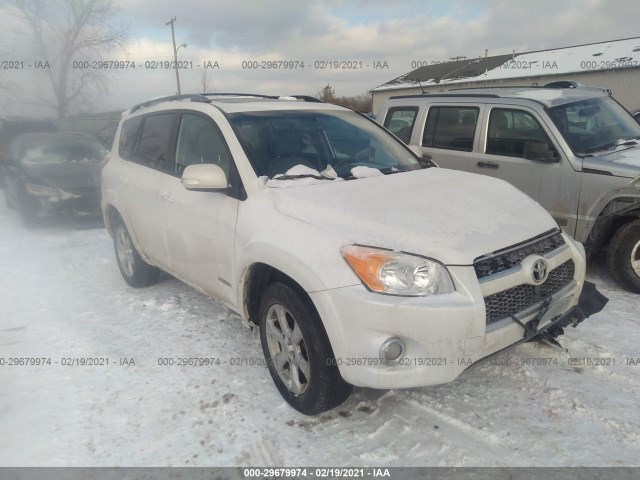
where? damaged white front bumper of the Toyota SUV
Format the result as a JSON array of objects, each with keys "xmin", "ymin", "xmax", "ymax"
[{"xmin": 310, "ymin": 240, "xmax": 604, "ymax": 389}]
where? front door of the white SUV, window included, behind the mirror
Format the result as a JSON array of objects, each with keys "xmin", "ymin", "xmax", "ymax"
[{"xmin": 160, "ymin": 111, "xmax": 240, "ymax": 303}]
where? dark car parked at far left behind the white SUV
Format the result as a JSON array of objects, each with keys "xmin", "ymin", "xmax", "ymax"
[{"xmin": 2, "ymin": 133, "xmax": 108, "ymax": 225}]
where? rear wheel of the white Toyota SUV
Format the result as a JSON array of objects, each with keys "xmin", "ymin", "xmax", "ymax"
[{"xmin": 113, "ymin": 220, "xmax": 160, "ymax": 288}]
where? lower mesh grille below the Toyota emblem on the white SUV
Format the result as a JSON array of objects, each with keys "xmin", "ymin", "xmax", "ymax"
[{"xmin": 484, "ymin": 260, "xmax": 575, "ymax": 325}]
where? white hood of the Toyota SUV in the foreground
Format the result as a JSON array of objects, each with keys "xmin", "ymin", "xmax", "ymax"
[{"xmin": 267, "ymin": 168, "xmax": 557, "ymax": 265}]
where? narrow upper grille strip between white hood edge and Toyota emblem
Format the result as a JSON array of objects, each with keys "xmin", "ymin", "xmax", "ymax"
[{"xmin": 473, "ymin": 232, "xmax": 564, "ymax": 280}]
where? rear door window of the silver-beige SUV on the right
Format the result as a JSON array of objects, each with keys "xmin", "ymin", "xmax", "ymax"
[{"xmin": 422, "ymin": 106, "xmax": 480, "ymax": 152}]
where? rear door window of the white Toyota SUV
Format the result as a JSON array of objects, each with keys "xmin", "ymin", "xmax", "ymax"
[{"xmin": 135, "ymin": 113, "xmax": 176, "ymax": 170}]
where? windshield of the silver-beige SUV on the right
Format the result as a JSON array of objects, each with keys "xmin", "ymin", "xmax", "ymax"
[{"xmin": 549, "ymin": 97, "xmax": 640, "ymax": 155}]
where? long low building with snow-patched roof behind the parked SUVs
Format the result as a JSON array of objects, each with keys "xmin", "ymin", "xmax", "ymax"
[{"xmin": 371, "ymin": 37, "xmax": 640, "ymax": 113}]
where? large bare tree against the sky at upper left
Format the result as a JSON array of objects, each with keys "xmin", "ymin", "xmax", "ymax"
[{"xmin": 11, "ymin": 0, "xmax": 127, "ymax": 118}]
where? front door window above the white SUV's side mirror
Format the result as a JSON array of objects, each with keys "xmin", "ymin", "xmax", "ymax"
[{"xmin": 174, "ymin": 113, "xmax": 231, "ymax": 178}]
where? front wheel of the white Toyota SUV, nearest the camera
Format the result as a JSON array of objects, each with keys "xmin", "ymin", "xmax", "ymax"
[{"xmin": 259, "ymin": 283, "xmax": 353, "ymax": 415}]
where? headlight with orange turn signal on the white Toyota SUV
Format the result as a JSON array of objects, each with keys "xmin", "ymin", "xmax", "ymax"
[{"xmin": 341, "ymin": 245, "xmax": 455, "ymax": 297}]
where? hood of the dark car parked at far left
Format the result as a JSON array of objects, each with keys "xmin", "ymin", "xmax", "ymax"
[{"xmin": 22, "ymin": 161, "xmax": 101, "ymax": 192}]
